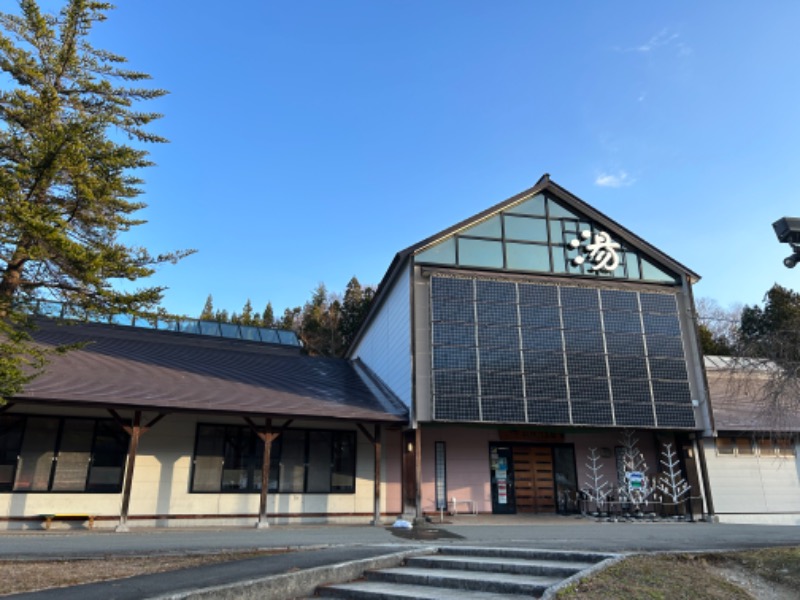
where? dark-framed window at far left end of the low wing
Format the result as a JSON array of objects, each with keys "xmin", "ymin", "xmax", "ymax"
[{"xmin": 0, "ymin": 415, "xmax": 128, "ymax": 493}]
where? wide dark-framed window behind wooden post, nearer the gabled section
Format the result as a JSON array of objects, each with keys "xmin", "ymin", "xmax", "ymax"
[{"xmin": 190, "ymin": 424, "xmax": 356, "ymax": 494}]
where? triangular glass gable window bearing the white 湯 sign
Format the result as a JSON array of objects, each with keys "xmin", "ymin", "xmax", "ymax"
[{"xmin": 415, "ymin": 194, "xmax": 680, "ymax": 284}]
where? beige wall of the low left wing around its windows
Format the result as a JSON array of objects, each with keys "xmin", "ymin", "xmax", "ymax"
[{"xmin": 0, "ymin": 407, "xmax": 400, "ymax": 528}]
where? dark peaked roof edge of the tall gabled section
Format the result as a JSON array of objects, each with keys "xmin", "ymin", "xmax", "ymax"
[{"xmin": 348, "ymin": 173, "xmax": 700, "ymax": 352}]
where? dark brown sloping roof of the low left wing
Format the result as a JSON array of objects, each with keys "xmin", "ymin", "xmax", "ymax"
[{"xmin": 18, "ymin": 321, "xmax": 407, "ymax": 422}]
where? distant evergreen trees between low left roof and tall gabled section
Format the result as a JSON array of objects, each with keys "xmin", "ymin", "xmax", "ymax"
[{"xmin": 198, "ymin": 277, "xmax": 375, "ymax": 357}]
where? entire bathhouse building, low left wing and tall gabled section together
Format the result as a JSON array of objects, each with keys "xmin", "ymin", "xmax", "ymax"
[{"xmin": 0, "ymin": 176, "xmax": 724, "ymax": 529}]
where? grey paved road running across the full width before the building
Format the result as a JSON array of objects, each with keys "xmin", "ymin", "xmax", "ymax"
[{"xmin": 0, "ymin": 515, "xmax": 800, "ymax": 558}]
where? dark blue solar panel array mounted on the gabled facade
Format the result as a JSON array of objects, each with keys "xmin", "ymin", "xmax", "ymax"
[{"xmin": 430, "ymin": 276, "xmax": 695, "ymax": 429}]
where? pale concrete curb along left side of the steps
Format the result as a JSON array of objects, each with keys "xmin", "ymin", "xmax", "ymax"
[{"xmin": 149, "ymin": 546, "xmax": 438, "ymax": 600}]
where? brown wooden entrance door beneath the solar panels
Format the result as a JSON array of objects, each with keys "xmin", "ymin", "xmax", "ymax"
[{"xmin": 514, "ymin": 446, "xmax": 556, "ymax": 513}]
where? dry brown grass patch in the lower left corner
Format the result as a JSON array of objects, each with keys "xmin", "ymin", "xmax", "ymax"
[{"xmin": 0, "ymin": 550, "xmax": 285, "ymax": 595}]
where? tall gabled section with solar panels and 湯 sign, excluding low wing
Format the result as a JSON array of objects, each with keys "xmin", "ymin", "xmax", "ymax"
[{"xmin": 349, "ymin": 175, "xmax": 712, "ymax": 516}]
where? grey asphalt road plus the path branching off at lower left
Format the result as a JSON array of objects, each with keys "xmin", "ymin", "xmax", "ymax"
[{"xmin": 0, "ymin": 517, "xmax": 800, "ymax": 600}]
